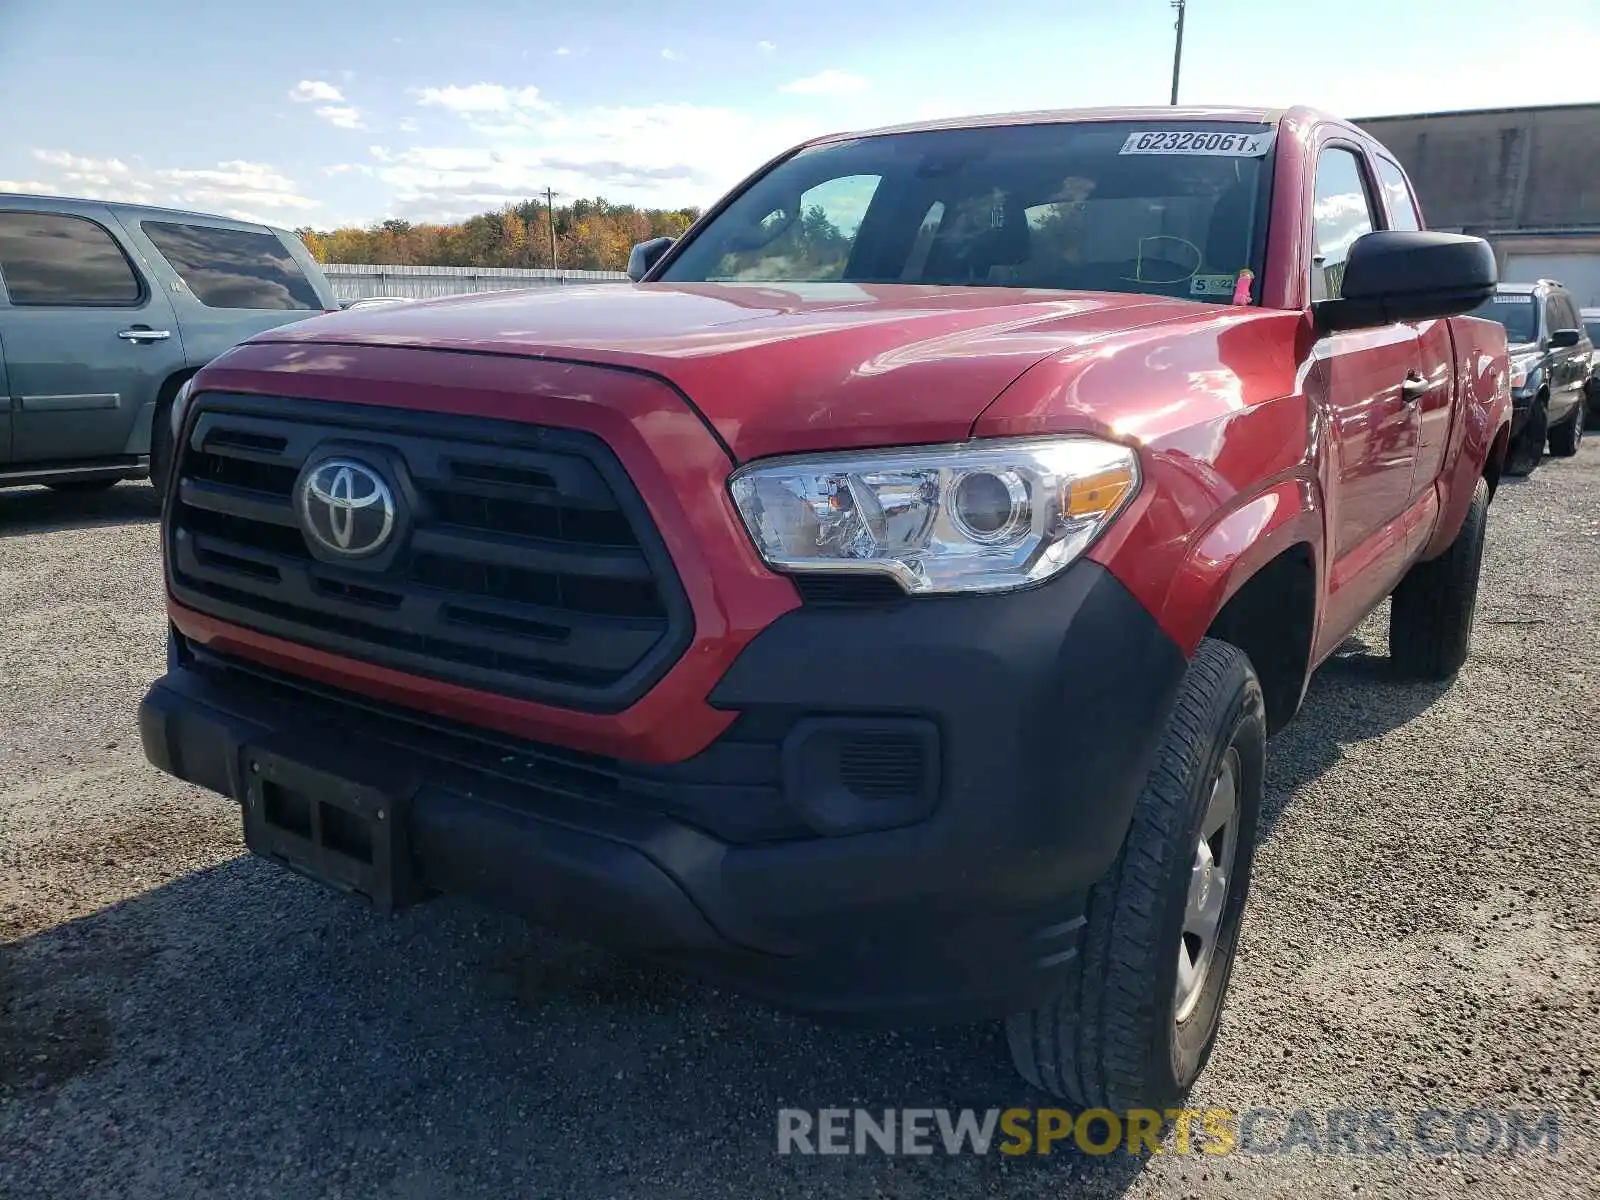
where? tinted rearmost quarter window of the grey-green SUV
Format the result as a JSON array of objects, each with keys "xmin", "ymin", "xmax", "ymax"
[{"xmin": 142, "ymin": 221, "xmax": 322, "ymax": 309}]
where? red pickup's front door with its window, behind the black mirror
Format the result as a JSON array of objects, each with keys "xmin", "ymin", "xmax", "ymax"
[{"xmin": 1309, "ymin": 141, "xmax": 1427, "ymax": 650}]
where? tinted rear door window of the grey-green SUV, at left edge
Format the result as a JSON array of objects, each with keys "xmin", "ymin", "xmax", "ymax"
[{"xmin": 0, "ymin": 213, "xmax": 144, "ymax": 307}]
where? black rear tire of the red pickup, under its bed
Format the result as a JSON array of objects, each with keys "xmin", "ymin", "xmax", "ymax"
[{"xmin": 1389, "ymin": 478, "xmax": 1490, "ymax": 680}]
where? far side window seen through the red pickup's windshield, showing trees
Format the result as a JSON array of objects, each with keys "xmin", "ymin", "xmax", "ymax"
[{"xmin": 709, "ymin": 174, "xmax": 882, "ymax": 282}]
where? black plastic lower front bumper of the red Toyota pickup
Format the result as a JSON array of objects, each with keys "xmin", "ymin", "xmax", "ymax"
[{"xmin": 139, "ymin": 563, "xmax": 1186, "ymax": 1021}]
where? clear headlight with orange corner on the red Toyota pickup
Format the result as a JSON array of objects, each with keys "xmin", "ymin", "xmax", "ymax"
[{"xmin": 730, "ymin": 437, "xmax": 1139, "ymax": 592}]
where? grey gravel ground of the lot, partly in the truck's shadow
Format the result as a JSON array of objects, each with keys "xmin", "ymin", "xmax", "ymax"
[{"xmin": 0, "ymin": 445, "xmax": 1600, "ymax": 1200}]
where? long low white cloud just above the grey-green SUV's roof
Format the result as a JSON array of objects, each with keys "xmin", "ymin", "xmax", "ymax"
[{"xmin": 24, "ymin": 150, "xmax": 318, "ymax": 224}]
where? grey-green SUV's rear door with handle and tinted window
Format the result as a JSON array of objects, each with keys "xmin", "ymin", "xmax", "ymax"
[{"xmin": 0, "ymin": 206, "xmax": 184, "ymax": 466}]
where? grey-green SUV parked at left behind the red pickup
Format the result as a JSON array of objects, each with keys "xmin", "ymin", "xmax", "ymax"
[{"xmin": 0, "ymin": 194, "xmax": 338, "ymax": 490}]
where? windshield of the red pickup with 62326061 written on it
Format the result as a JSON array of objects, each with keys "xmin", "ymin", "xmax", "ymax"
[{"xmin": 661, "ymin": 122, "xmax": 1274, "ymax": 304}]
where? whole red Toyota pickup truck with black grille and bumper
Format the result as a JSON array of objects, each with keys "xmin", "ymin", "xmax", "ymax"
[{"xmin": 139, "ymin": 109, "xmax": 1510, "ymax": 1107}]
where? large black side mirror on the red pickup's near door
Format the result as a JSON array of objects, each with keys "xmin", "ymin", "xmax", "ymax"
[{"xmin": 1315, "ymin": 230, "xmax": 1499, "ymax": 330}]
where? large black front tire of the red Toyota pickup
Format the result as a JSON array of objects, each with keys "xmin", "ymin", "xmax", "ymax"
[{"xmin": 1006, "ymin": 638, "xmax": 1267, "ymax": 1112}]
